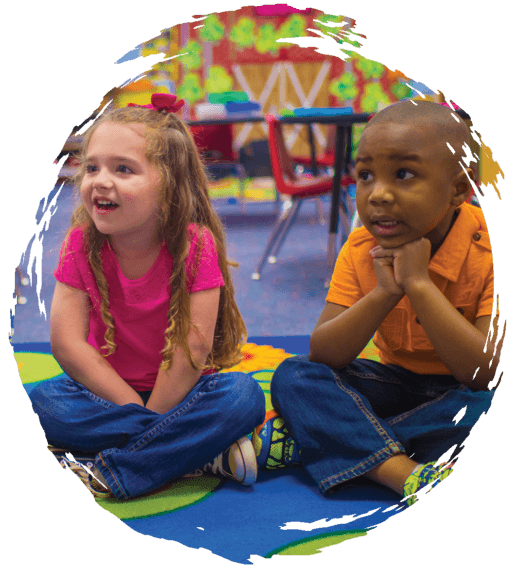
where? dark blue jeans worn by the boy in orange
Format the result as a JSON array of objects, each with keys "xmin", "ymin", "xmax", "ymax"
[{"xmin": 271, "ymin": 355, "xmax": 494, "ymax": 494}]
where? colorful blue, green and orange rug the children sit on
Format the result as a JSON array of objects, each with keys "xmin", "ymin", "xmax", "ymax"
[{"xmin": 12, "ymin": 337, "xmax": 412, "ymax": 565}]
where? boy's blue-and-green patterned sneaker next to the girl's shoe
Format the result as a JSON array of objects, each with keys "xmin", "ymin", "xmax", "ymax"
[{"xmin": 252, "ymin": 410, "xmax": 301, "ymax": 469}]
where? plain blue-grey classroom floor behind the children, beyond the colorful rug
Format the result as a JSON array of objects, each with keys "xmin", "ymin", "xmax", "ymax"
[{"xmin": 12, "ymin": 186, "xmax": 350, "ymax": 343}]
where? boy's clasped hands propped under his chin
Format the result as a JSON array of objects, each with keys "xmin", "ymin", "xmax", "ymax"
[{"xmin": 370, "ymin": 237, "xmax": 431, "ymax": 292}]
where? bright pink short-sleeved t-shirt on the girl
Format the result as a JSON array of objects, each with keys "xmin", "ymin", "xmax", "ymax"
[{"xmin": 54, "ymin": 223, "xmax": 224, "ymax": 391}]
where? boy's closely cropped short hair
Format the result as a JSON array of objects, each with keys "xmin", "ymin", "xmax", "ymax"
[{"xmin": 363, "ymin": 100, "xmax": 471, "ymax": 175}]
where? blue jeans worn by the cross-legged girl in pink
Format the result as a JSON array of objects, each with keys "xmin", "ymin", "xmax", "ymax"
[{"xmin": 29, "ymin": 373, "xmax": 265, "ymax": 500}]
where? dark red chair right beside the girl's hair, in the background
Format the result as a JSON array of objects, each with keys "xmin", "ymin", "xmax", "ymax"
[{"xmin": 189, "ymin": 123, "xmax": 245, "ymax": 198}]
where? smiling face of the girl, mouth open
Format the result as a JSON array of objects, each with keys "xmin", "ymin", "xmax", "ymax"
[{"xmin": 80, "ymin": 122, "xmax": 160, "ymax": 245}]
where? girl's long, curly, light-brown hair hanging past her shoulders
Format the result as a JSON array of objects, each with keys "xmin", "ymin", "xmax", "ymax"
[{"xmin": 65, "ymin": 103, "xmax": 247, "ymax": 370}]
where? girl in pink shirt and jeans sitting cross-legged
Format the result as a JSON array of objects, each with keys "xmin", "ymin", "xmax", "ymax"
[{"xmin": 29, "ymin": 94, "xmax": 265, "ymax": 500}]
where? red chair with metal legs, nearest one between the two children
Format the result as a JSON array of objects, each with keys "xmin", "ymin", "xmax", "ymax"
[{"xmin": 252, "ymin": 114, "xmax": 354, "ymax": 280}]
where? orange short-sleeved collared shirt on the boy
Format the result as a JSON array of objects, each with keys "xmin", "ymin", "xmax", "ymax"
[{"xmin": 326, "ymin": 203, "xmax": 494, "ymax": 375}]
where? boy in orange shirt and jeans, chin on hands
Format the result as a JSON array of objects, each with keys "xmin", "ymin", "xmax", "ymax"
[{"xmin": 253, "ymin": 100, "xmax": 504, "ymax": 505}]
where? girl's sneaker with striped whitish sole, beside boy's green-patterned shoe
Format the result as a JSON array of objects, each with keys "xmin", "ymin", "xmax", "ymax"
[{"xmin": 184, "ymin": 436, "xmax": 257, "ymax": 485}]
